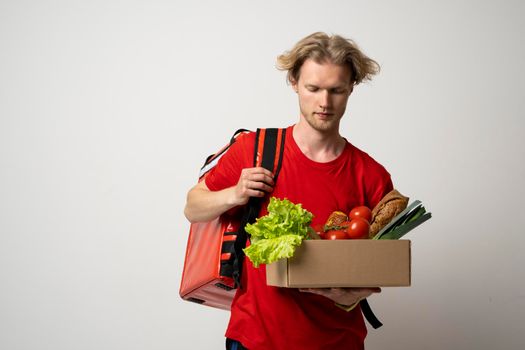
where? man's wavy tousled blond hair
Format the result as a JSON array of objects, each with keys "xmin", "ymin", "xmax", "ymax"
[{"xmin": 277, "ymin": 32, "xmax": 380, "ymax": 85}]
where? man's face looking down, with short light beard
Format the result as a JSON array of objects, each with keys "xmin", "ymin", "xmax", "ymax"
[{"xmin": 292, "ymin": 59, "xmax": 353, "ymax": 133}]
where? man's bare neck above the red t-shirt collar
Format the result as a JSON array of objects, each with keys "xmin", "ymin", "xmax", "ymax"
[{"xmin": 293, "ymin": 120, "xmax": 346, "ymax": 163}]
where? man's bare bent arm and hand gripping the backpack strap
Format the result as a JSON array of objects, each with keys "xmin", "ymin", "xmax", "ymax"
[{"xmin": 184, "ymin": 167, "xmax": 274, "ymax": 222}]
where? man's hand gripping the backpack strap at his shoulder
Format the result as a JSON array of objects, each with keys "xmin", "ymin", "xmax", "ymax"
[{"xmin": 233, "ymin": 167, "xmax": 275, "ymax": 205}]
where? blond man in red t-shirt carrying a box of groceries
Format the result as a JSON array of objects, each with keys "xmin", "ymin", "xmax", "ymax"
[{"xmin": 185, "ymin": 33, "xmax": 393, "ymax": 350}]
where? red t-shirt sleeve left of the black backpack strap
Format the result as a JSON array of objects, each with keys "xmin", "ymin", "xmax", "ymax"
[{"xmin": 204, "ymin": 133, "xmax": 255, "ymax": 191}]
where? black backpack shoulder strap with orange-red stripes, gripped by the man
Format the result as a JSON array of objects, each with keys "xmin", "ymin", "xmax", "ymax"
[{"xmin": 232, "ymin": 128, "xmax": 286, "ymax": 287}]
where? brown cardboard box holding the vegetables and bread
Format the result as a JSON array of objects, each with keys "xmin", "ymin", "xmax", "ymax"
[{"xmin": 266, "ymin": 239, "xmax": 410, "ymax": 288}]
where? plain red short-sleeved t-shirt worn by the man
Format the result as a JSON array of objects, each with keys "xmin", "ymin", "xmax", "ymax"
[{"xmin": 206, "ymin": 126, "xmax": 393, "ymax": 350}]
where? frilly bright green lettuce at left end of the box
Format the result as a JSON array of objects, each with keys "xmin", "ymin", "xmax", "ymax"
[{"xmin": 244, "ymin": 197, "xmax": 313, "ymax": 267}]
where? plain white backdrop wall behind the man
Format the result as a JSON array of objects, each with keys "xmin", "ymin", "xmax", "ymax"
[{"xmin": 0, "ymin": 0, "xmax": 525, "ymax": 350}]
